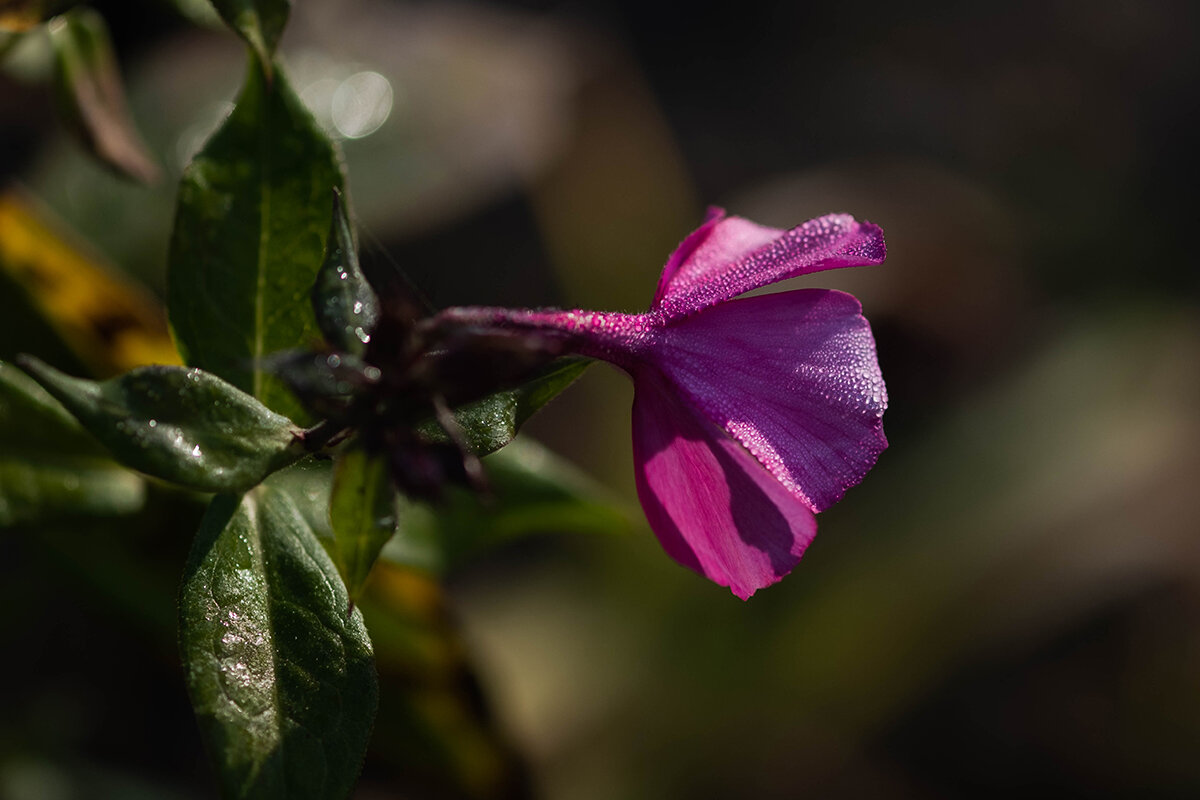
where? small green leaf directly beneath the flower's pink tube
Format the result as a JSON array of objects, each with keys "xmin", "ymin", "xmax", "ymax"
[{"xmin": 421, "ymin": 357, "xmax": 592, "ymax": 456}]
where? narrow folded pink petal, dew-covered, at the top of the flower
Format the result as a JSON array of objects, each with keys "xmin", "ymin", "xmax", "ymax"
[{"xmin": 650, "ymin": 209, "xmax": 887, "ymax": 318}]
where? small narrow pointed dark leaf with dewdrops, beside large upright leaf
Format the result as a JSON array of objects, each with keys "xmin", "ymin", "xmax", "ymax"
[{"xmin": 312, "ymin": 192, "xmax": 379, "ymax": 356}]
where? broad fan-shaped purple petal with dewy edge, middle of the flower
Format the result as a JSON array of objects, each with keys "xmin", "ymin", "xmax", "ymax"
[{"xmin": 650, "ymin": 289, "xmax": 887, "ymax": 511}]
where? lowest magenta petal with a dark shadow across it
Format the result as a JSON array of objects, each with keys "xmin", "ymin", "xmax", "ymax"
[{"xmin": 634, "ymin": 367, "xmax": 816, "ymax": 600}]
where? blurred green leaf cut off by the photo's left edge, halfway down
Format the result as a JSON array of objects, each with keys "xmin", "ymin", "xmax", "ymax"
[{"xmin": 0, "ymin": 361, "xmax": 145, "ymax": 528}]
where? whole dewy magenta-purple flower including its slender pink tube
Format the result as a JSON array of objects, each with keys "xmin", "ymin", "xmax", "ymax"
[{"xmin": 442, "ymin": 209, "xmax": 887, "ymax": 599}]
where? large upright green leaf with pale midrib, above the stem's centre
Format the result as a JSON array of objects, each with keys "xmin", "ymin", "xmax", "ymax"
[{"xmin": 167, "ymin": 64, "xmax": 342, "ymax": 420}]
